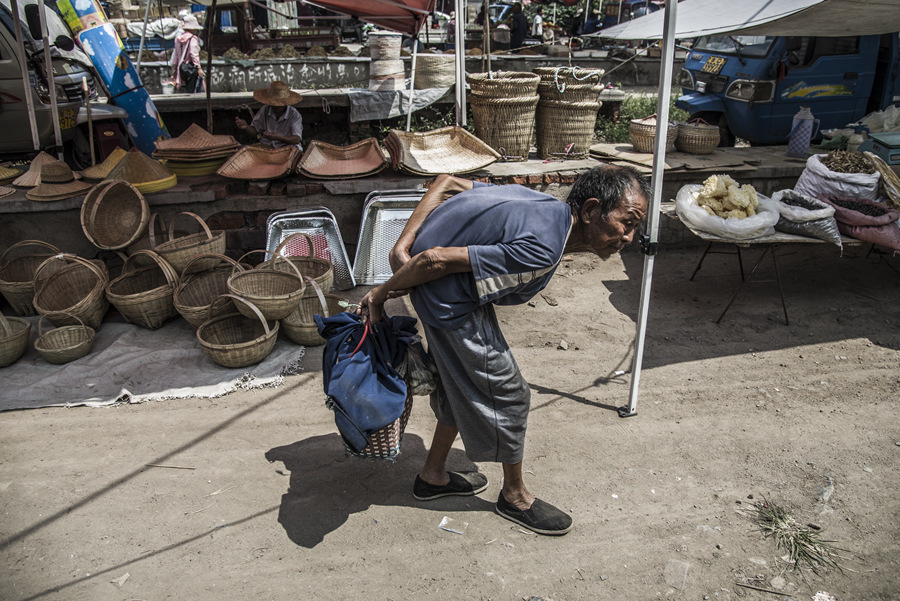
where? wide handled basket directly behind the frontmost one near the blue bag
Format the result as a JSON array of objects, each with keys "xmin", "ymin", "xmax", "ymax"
[{"xmin": 228, "ymin": 250, "xmax": 306, "ymax": 320}]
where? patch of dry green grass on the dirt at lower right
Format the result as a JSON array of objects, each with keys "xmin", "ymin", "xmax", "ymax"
[{"xmin": 749, "ymin": 500, "xmax": 844, "ymax": 574}]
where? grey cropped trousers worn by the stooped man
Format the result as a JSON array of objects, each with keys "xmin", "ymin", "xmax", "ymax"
[{"xmin": 422, "ymin": 305, "xmax": 531, "ymax": 463}]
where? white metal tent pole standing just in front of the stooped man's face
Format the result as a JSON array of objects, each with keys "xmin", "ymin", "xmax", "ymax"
[{"xmin": 618, "ymin": 2, "xmax": 678, "ymax": 417}]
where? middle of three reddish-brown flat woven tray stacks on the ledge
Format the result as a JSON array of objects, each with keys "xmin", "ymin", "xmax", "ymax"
[{"xmin": 297, "ymin": 138, "xmax": 387, "ymax": 179}]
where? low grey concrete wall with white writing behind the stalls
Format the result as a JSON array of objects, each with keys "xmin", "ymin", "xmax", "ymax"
[{"xmin": 141, "ymin": 52, "xmax": 681, "ymax": 94}]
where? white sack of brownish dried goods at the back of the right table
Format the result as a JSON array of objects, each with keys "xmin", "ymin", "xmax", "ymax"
[{"xmin": 794, "ymin": 150, "xmax": 881, "ymax": 200}]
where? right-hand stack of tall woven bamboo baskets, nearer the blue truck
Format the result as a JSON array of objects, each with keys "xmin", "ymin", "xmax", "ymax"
[{"xmin": 534, "ymin": 67, "xmax": 605, "ymax": 159}]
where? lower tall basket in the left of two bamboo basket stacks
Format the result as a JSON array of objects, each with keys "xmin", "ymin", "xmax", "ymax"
[{"xmin": 471, "ymin": 96, "xmax": 540, "ymax": 161}]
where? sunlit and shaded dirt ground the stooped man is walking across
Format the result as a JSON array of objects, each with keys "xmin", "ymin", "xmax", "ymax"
[{"xmin": 0, "ymin": 244, "xmax": 900, "ymax": 601}]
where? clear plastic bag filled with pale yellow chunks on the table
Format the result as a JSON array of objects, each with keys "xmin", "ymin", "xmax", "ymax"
[{"xmin": 675, "ymin": 175, "xmax": 779, "ymax": 240}]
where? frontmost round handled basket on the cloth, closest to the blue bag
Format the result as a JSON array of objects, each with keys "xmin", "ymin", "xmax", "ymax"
[{"xmin": 197, "ymin": 294, "xmax": 279, "ymax": 367}]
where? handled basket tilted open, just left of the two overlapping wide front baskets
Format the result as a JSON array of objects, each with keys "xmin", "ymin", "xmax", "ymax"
[{"xmin": 172, "ymin": 254, "xmax": 241, "ymax": 328}]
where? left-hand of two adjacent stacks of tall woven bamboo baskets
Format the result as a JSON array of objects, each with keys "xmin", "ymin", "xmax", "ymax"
[{"xmin": 466, "ymin": 72, "xmax": 541, "ymax": 161}]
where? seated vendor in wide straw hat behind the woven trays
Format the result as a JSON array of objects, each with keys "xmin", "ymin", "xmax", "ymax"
[{"xmin": 234, "ymin": 81, "xmax": 303, "ymax": 150}]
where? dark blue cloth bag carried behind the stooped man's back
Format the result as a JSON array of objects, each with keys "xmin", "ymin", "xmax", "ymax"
[{"xmin": 315, "ymin": 313, "xmax": 416, "ymax": 453}]
